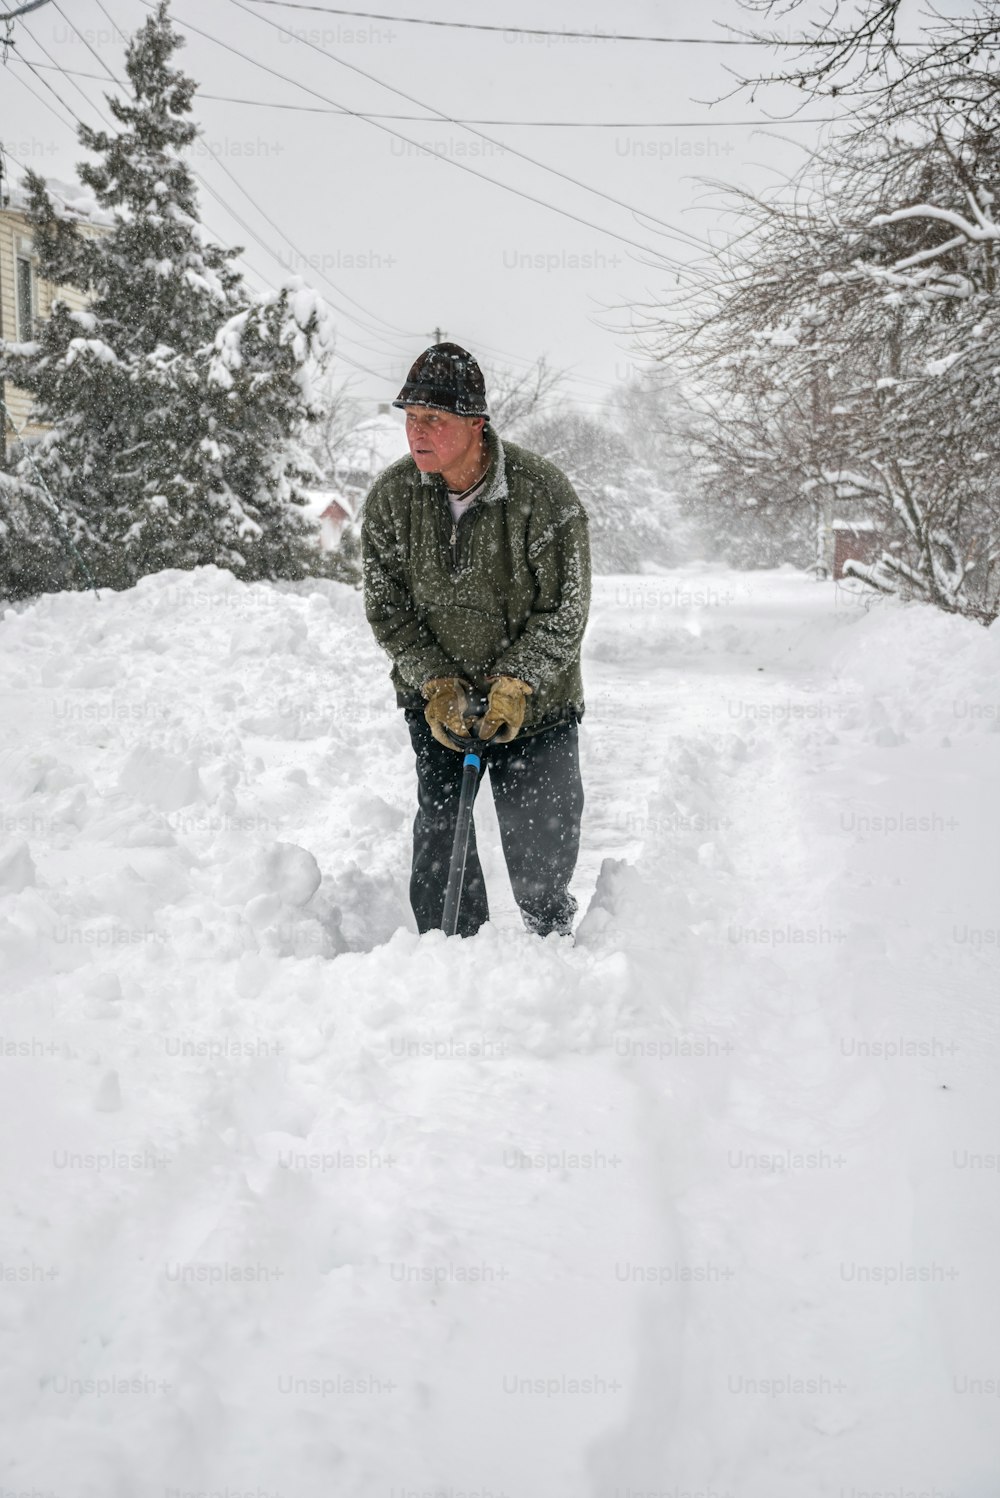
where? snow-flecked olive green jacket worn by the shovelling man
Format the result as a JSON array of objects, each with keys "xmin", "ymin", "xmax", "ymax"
[{"xmin": 361, "ymin": 427, "xmax": 590, "ymax": 734}]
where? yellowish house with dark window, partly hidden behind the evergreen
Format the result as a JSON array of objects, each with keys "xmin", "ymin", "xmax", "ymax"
[{"xmin": 0, "ymin": 177, "xmax": 114, "ymax": 463}]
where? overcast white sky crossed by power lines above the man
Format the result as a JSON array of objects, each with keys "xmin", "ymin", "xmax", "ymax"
[{"xmin": 0, "ymin": 0, "xmax": 856, "ymax": 413}]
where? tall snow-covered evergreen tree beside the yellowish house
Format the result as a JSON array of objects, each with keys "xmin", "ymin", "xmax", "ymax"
[{"xmin": 0, "ymin": 0, "xmax": 332, "ymax": 587}]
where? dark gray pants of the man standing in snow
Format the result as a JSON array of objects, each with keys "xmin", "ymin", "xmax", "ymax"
[{"xmin": 406, "ymin": 712, "xmax": 584, "ymax": 936}]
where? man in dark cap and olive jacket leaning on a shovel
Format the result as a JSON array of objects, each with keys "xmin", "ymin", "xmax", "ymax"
[{"xmin": 361, "ymin": 343, "xmax": 590, "ymax": 936}]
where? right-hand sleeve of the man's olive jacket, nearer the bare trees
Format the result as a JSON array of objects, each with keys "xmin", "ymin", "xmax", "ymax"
[{"xmin": 491, "ymin": 475, "xmax": 590, "ymax": 691}]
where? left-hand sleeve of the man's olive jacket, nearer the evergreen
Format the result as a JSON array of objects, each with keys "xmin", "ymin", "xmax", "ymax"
[{"xmin": 361, "ymin": 484, "xmax": 460, "ymax": 689}]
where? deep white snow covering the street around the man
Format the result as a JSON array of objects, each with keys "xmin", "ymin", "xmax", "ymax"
[{"xmin": 0, "ymin": 566, "xmax": 1000, "ymax": 1498}]
